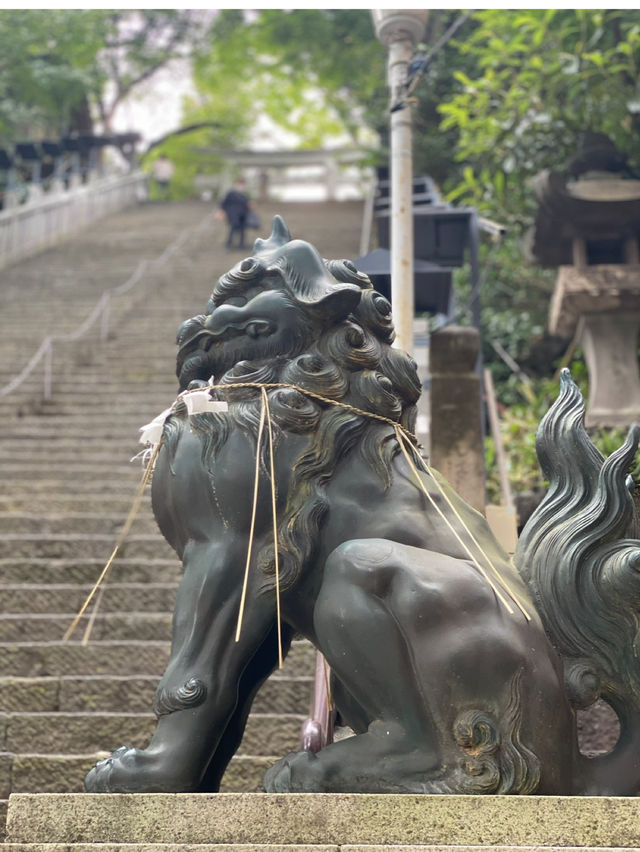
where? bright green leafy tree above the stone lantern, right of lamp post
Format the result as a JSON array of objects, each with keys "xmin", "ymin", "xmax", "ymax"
[{"xmin": 439, "ymin": 9, "xmax": 640, "ymax": 223}]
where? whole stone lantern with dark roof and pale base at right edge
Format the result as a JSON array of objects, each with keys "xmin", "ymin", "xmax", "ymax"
[{"xmin": 528, "ymin": 134, "xmax": 640, "ymax": 427}]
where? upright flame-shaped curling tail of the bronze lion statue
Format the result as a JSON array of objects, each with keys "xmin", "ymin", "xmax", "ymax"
[{"xmin": 515, "ymin": 370, "xmax": 640, "ymax": 795}]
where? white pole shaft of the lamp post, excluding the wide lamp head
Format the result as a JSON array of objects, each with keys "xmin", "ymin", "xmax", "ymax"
[{"xmin": 389, "ymin": 38, "xmax": 415, "ymax": 355}]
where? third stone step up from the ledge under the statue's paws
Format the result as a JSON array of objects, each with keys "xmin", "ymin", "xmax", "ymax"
[{"xmin": 0, "ymin": 676, "xmax": 313, "ymax": 715}]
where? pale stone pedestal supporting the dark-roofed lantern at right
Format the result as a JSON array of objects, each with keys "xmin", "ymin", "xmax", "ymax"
[{"xmin": 549, "ymin": 264, "xmax": 640, "ymax": 428}]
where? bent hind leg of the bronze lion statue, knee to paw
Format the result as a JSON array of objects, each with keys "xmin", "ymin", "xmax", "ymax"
[{"xmin": 265, "ymin": 540, "xmax": 442, "ymax": 792}]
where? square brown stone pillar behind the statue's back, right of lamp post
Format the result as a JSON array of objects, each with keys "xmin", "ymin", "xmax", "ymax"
[{"xmin": 429, "ymin": 326, "xmax": 485, "ymax": 512}]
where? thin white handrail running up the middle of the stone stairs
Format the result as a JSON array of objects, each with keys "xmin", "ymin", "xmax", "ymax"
[{"xmin": 0, "ymin": 211, "xmax": 216, "ymax": 399}]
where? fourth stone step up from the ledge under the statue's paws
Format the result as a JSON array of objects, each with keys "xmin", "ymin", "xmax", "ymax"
[{"xmin": 0, "ymin": 640, "xmax": 315, "ymax": 677}]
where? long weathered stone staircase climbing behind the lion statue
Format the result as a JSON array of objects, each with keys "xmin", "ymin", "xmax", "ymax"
[{"xmin": 0, "ymin": 198, "xmax": 360, "ymax": 840}]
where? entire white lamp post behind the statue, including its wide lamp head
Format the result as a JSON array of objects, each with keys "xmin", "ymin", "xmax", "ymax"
[{"xmin": 371, "ymin": 9, "xmax": 429, "ymax": 354}]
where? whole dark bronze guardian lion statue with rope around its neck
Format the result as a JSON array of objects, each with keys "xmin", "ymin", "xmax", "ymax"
[{"xmin": 86, "ymin": 217, "xmax": 640, "ymax": 795}]
